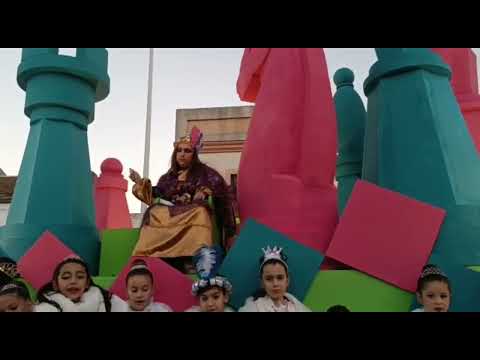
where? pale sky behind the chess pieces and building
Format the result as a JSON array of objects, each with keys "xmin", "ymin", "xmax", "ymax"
[{"xmin": 0, "ymin": 48, "xmax": 480, "ymax": 212}]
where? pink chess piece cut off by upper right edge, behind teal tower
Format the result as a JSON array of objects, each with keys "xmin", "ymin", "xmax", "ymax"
[{"xmin": 432, "ymin": 48, "xmax": 480, "ymax": 152}]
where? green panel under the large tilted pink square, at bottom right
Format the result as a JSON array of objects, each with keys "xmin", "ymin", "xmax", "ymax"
[{"xmin": 304, "ymin": 270, "xmax": 414, "ymax": 312}]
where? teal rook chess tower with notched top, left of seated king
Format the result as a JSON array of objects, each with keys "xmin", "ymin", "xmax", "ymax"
[{"xmin": 0, "ymin": 48, "xmax": 110, "ymax": 274}]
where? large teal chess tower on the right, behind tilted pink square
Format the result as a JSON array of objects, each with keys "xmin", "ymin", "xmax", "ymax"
[{"xmin": 363, "ymin": 48, "xmax": 480, "ymax": 265}]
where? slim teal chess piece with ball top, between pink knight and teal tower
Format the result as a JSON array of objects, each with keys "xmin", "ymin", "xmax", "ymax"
[{"xmin": 333, "ymin": 68, "xmax": 367, "ymax": 215}]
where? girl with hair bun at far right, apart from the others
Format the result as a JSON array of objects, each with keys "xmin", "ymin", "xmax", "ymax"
[{"xmin": 413, "ymin": 265, "xmax": 452, "ymax": 312}]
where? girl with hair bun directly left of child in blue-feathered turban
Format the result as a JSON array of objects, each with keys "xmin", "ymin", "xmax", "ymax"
[{"xmin": 125, "ymin": 259, "xmax": 172, "ymax": 312}]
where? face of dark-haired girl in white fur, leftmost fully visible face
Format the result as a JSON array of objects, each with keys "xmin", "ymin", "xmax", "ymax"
[{"xmin": 56, "ymin": 263, "xmax": 90, "ymax": 302}]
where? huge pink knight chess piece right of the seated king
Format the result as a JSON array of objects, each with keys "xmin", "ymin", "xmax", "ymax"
[{"xmin": 237, "ymin": 48, "xmax": 338, "ymax": 252}]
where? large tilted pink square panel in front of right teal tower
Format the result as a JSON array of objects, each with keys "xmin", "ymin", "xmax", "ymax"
[{"xmin": 327, "ymin": 180, "xmax": 445, "ymax": 292}]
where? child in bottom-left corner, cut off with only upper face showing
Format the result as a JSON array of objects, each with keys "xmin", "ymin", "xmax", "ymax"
[{"xmin": 0, "ymin": 281, "xmax": 58, "ymax": 313}]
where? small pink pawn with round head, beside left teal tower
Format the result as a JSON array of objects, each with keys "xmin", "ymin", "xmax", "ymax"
[{"xmin": 95, "ymin": 158, "xmax": 132, "ymax": 230}]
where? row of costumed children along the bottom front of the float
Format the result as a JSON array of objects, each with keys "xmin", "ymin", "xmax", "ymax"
[{"xmin": 0, "ymin": 247, "xmax": 452, "ymax": 312}]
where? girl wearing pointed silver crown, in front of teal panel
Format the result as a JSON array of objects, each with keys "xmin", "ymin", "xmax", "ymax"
[{"xmin": 239, "ymin": 247, "xmax": 311, "ymax": 312}]
